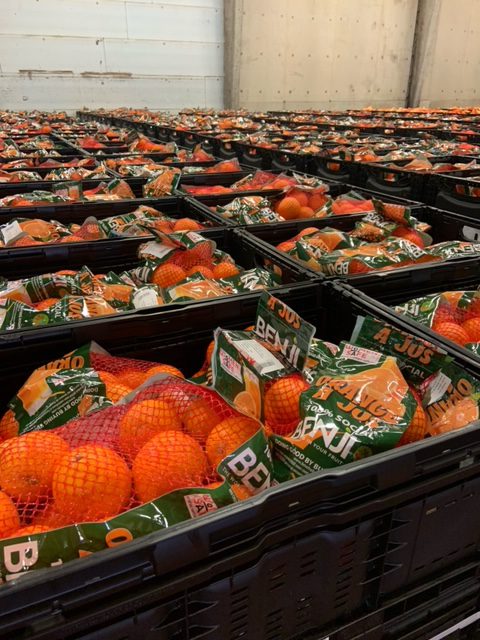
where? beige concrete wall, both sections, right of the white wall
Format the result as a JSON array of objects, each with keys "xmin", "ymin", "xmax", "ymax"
[{"xmin": 225, "ymin": 0, "xmax": 480, "ymax": 109}]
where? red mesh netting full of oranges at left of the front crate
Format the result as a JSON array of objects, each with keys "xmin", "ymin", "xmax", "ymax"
[{"xmin": 0, "ymin": 376, "xmax": 259, "ymax": 537}]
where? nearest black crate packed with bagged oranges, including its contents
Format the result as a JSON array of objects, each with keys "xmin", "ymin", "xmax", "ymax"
[{"xmin": 0, "ymin": 284, "xmax": 479, "ymax": 639}]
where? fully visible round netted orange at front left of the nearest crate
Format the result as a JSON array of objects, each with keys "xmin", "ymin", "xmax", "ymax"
[{"xmin": 52, "ymin": 444, "xmax": 132, "ymax": 522}]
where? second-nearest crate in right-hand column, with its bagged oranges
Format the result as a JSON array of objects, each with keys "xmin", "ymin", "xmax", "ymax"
[{"xmin": 239, "ymin": 200, "xmax": 480, "ymax": 278}]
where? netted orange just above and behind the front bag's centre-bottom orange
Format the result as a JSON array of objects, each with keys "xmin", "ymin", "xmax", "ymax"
[{"xmin": 119, "ymin": 399, "xmax": 182, "ymax": 459}]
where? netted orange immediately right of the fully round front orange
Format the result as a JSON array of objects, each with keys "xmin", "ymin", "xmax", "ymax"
[{"xmin": 132, "ymin": 431, "xmax": 208, "ymax": 502}]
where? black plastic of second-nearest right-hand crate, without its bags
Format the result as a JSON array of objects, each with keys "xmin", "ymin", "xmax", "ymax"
[{"xmin": 238, "ymin": 205, "xmax": 480, "ymax": 282}]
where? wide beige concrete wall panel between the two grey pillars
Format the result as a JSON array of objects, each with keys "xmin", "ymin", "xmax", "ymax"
[{"xmin": 225, "ymin": 0, "xmax": 417, "ymax": 109}]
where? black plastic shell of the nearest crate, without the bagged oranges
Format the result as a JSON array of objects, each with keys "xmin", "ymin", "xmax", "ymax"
[{"xmin": 0, "ymin": 284, "xmax": 480, "ymax": 640}]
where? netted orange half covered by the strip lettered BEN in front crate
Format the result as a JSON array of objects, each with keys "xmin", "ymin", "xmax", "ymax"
[{"xmin": 206, "ymin": 416, "xmax": 260, "ymax": 469}]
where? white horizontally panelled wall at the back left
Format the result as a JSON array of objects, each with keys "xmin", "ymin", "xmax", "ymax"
[{"xmin": 0, "ymin": 0, "xmax": 223, "ymax": 110}]
